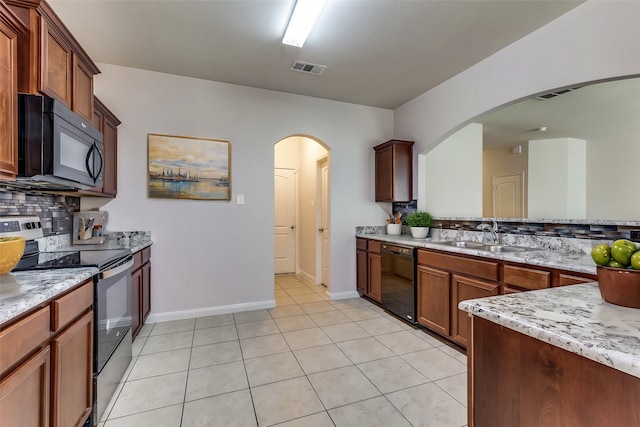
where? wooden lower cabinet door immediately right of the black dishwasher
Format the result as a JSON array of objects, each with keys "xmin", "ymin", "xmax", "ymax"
[{"xmin": 417, "ymin": 265, "xmax": 451, "ymax": 336}]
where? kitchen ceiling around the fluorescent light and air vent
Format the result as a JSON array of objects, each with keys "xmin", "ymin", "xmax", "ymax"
[{"xmin": 48, "ymin": 0, "xmax": 581, "ymax": 109}]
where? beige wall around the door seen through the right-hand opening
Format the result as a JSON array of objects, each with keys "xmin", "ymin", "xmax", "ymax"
[{"xmin": 482, "ymin": 143, "xmax": 529, "ymax": 217}]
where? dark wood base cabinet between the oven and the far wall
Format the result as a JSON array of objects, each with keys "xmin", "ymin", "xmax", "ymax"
[{"xmin": 131, "ymin": 246, "xmax": 151, "ymax": 338}]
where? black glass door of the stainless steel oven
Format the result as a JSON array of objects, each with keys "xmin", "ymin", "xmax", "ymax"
[{"xmin": 94, "ymin": 257, "xmax": 133, "ymax": 373}]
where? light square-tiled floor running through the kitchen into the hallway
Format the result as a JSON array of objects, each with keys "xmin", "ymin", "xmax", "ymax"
[{"xmin": 99, "ymin": 275, "xmax": 467, "ymax": 427}]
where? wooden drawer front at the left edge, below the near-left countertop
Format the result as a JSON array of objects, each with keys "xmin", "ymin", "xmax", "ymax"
[{"xmin": 0, "ymin": 306, "xmax": 51, "ymax": 375}]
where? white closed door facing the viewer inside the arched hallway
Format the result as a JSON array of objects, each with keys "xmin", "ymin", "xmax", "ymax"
[{"xmin": 274, "ymin": 169, "xmax": 298, "ymax": 274}]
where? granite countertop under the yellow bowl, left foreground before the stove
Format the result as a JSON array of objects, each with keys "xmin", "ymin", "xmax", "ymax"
[{"xmin": 0, "ymin": 267, "xmax": 98, "ymax": 324}]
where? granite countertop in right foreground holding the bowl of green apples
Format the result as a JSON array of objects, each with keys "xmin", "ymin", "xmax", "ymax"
[{"xmin": 459, "ymin": 283, "xmax": 640, "ymax": 378}]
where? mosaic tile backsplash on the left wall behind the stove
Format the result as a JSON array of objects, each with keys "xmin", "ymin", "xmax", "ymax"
[{"xmin": 0, "ymin": 184, "xmax": 80, "ymax": 236}]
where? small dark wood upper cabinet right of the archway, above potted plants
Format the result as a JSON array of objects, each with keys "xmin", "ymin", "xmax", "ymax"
[{"xmin": 373, "ymin": 139, "xmax": 413, "ymax": 202}]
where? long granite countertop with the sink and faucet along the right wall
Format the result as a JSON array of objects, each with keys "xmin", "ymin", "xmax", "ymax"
[{"xmin": 356, "ymin": 233, "xmax": 596, "ymax": 276}]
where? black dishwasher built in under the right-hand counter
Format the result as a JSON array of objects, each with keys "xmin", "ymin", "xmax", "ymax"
[{"xmin": 380, "ymin": 243, "xmax": 416, "ymax": 324}]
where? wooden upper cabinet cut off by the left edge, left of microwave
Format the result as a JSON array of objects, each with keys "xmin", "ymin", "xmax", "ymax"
[{"xmin": 0, "ymin": 1, "xmax": 27, "ymax": 179}]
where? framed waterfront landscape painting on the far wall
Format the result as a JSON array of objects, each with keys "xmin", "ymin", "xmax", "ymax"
[{"xmin": 147, "ymin": 133, "xmax": 231, "ymax": 201}]
